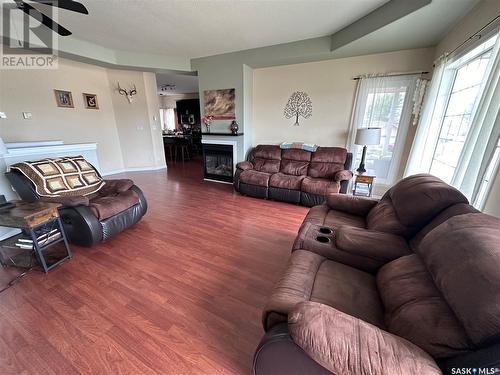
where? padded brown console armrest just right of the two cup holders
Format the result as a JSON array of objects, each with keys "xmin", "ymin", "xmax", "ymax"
[{"xmin": 335, "ymin": 226, "xmax": 412, "ymax": 264}]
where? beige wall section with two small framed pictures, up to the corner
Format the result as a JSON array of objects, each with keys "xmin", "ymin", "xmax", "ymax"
[{"xmin": 0, "ymin": 59, "xmax": 123, "ymax": 171}]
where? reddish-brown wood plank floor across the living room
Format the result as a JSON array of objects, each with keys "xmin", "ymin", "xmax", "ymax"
[{"xmin": 0, "ymin": 161, "xmax": 307, "ymax": 375}]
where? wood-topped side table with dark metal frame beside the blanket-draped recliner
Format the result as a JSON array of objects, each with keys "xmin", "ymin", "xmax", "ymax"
[{"xmin": 0, "ymin": 201, "xmax": 72, "ymax": 273}]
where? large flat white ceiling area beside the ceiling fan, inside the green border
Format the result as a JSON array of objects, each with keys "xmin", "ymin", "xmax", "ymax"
[{"xmin": 46, "ymin": 0, "xmax": 390, "ymax": 57}]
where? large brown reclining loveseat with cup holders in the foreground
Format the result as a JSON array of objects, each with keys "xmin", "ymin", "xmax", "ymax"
[{"xmin": 254, "ymin": 175, "xmax": 500, "ymax": 375}]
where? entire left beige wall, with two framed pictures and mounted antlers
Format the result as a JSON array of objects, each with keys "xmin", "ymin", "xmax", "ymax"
[{"xmin": 0, "ymin": 59, "xmax": 165, "ymax": 173}]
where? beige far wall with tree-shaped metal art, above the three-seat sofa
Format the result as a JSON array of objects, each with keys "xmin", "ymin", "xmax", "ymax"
[{"xmin": 252, "ymin": 48, "xmax": 434, "ymax": 150}]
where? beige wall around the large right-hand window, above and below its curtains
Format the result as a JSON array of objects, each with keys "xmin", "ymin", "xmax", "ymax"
[{"xmin": 435, "ymin": 0, "xmax": 500, "ymax": 217}]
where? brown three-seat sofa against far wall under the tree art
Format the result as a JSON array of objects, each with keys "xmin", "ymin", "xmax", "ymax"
[{"xmin": 234, "ymin": 145, "xmax": 352, "ymax": 207}]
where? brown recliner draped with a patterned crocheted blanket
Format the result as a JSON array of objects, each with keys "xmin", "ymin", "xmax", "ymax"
[{"xmin": 5, "ymin": 156, "xmax": 147, "ymax": 246}]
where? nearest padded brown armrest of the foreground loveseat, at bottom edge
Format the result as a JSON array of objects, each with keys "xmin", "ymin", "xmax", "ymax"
[{"xmin": 288, "ymin": 302, "xmax": 441, "ymax": 374}]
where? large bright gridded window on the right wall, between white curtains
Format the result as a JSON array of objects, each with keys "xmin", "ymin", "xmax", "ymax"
[{"xmin": 430, "ymin": 36, "xmax": 497, "ymax": 183}]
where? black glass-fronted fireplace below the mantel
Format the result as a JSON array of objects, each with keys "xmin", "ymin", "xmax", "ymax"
[{"xmin": 203, "ymin": 143, "xmax": 234, "ymax": 183}]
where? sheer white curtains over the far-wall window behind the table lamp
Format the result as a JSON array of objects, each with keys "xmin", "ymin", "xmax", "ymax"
[{"xmin": 347, "ymin": 74, "xmax": 419, "ymax": 184}]
